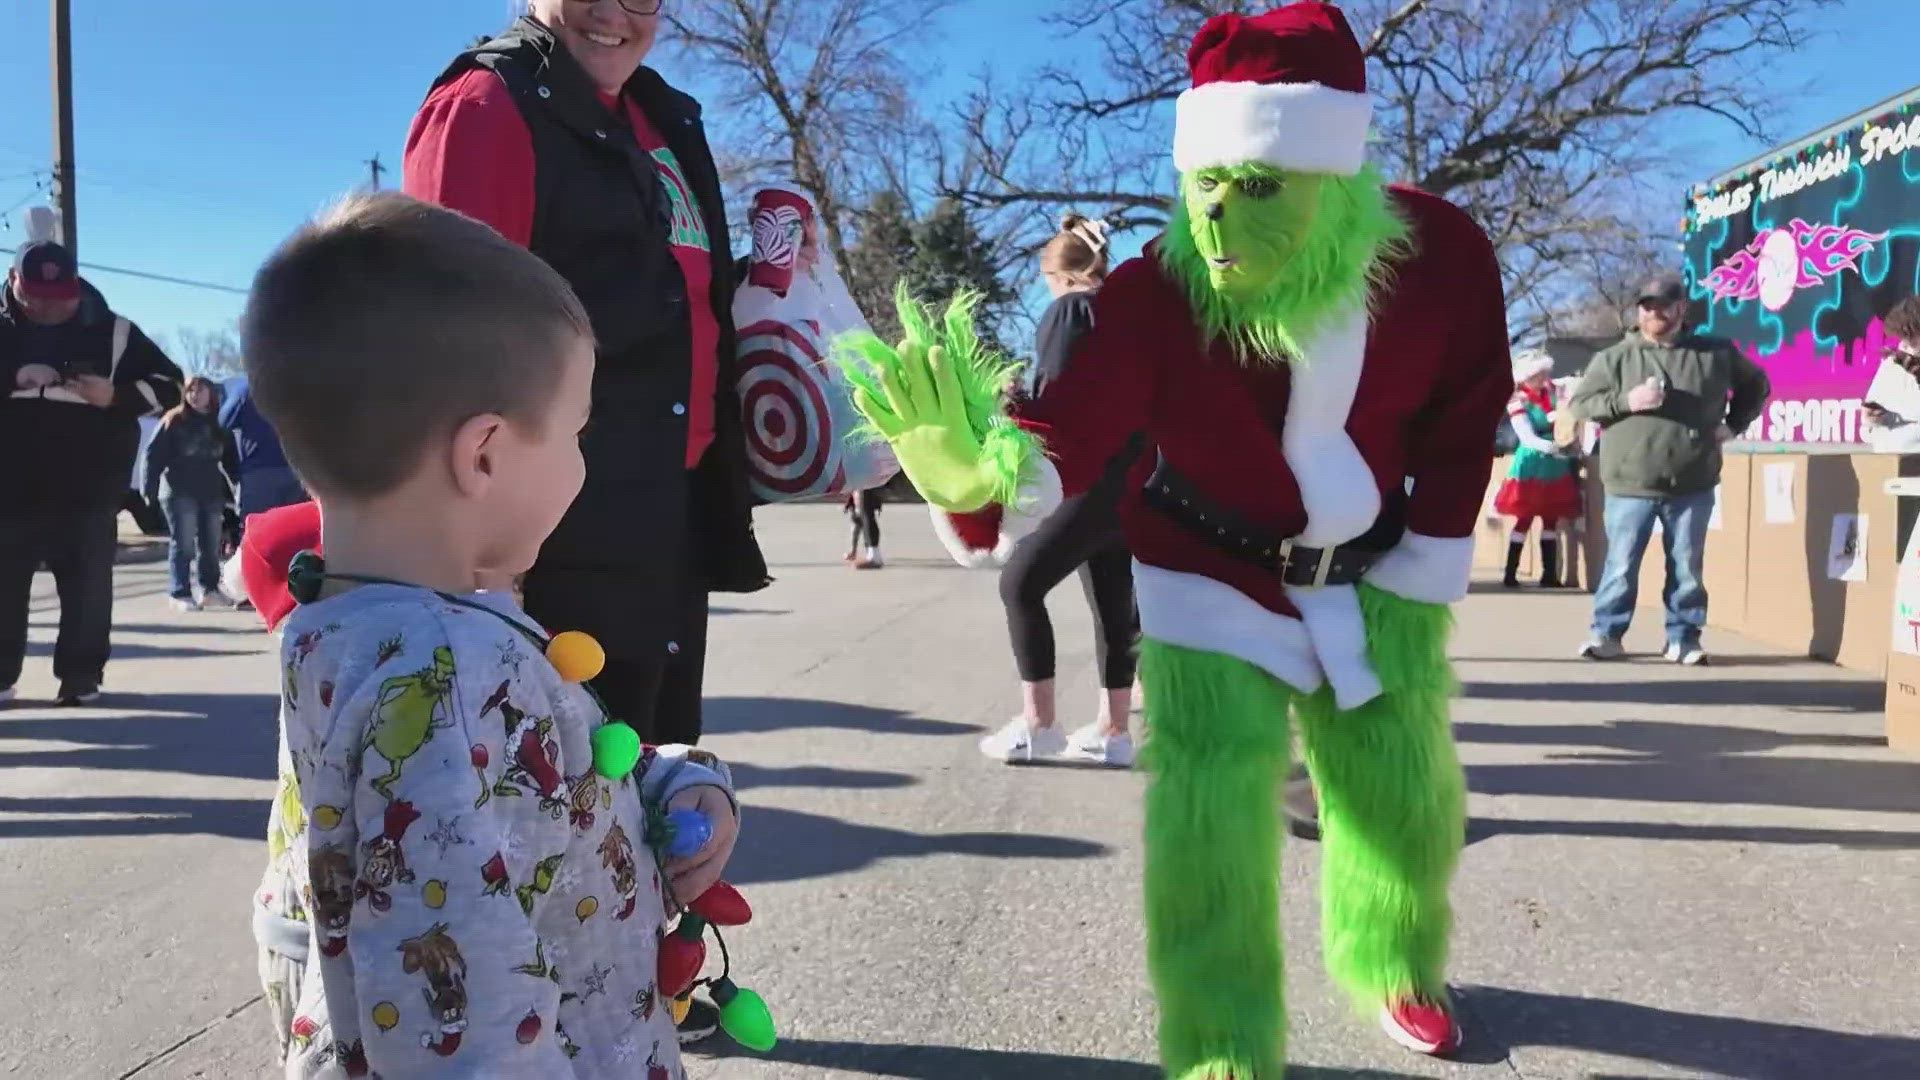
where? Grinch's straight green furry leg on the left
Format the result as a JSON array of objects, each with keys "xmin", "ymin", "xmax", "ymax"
[{"xmin": 1140, "ymin": 640, "xmax": 1292, "ymax": 1080}]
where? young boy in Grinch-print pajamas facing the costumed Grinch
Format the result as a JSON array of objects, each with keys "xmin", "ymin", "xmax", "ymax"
[{"xmin": 242, "ymin": 194, "xmax": 737, "ymax": 1080}]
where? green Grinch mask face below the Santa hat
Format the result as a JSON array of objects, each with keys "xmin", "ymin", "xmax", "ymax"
[{"xmin": 1181, "ymin": 165, "xmax": 1325, "ymax": 298}]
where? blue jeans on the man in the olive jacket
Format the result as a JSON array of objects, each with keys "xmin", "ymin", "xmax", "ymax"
[{"xmin": 1594, "ymin": 488, "xmax": 1713, "ymax": 646}]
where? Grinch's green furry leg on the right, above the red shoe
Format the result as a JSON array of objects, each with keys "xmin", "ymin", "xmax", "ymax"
[{"xmin": 1296, "ymin": 586, "xmax": 1467, "ymax": 1013}]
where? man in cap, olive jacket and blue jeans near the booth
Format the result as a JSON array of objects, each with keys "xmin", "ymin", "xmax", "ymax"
[{"xmin": 1572, "ymin": 275, "xmax": 1772, "ymax": 665}]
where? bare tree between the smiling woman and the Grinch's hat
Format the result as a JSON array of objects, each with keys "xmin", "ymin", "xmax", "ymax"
[{"xmin": 666, "ymin": 0, "xmax": 952, "ymax": 273}]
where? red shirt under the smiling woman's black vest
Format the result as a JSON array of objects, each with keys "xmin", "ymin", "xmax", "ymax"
[{"xmin": 401, "ymin": 69, "xmax": 720, "ymax": 469}]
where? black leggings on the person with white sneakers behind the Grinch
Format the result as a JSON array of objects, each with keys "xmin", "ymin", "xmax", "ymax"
[{"xmin": 1000, "ymin": 492, "xmax": 1140, "ymax": 690}]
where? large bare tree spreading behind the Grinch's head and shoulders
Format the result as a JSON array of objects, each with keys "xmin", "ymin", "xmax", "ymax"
[{"xmin": 941, "ymin": 0, "xmax": 1836, "ymax": 338}]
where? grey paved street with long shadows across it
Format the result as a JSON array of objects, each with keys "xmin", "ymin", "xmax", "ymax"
[{"xmin": 0, "ymin": 505, "xmax": 1920, "ymax": 1080}]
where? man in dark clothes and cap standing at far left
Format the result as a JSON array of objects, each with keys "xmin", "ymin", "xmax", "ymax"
[{"xmin": 0, "ymin": 240, "xmax": 180, "ymax": 707}]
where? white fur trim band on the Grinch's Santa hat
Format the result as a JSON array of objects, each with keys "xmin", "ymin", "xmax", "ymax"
[{"xmin": 1173, "ymin": 83, "xmax": 1373, "ymax": 177}]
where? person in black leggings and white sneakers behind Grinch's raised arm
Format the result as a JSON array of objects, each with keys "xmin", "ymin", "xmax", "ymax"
[{"xmin": 979, "ymin": 215, "xmax": 1140, "ymax": 769}]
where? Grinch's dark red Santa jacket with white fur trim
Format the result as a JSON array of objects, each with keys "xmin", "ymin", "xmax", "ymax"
[{"xmin": 1021, "ymin": 188, "xmax": 1513, "ymax": 707}]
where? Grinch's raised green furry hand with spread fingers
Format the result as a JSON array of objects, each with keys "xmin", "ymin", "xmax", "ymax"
[{"xmin": 835, "ymin": 288, "xmax": 1039, "ymax": 513}]
